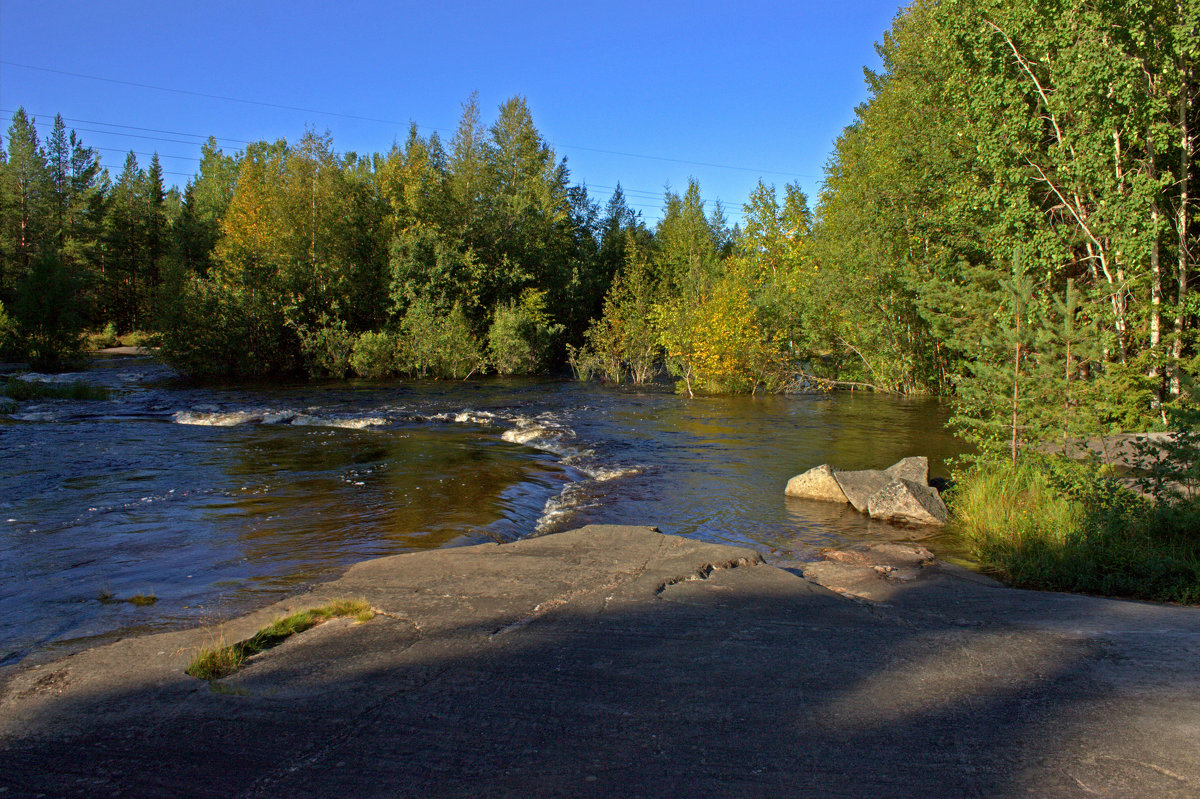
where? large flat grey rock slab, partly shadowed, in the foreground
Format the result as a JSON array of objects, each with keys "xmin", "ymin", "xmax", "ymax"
[{"xmin": 0, "ymin": 527, "xmax": 1200, "ymax": 799}]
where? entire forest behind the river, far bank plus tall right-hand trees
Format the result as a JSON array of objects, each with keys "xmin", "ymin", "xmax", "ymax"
[{"xmin": 0, "ymin": 0, "xmax": 1200, "ymax": 452}]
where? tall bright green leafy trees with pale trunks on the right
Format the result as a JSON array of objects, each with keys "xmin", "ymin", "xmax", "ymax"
[{"xmin": 815, "ymin": 0, "xmax": 1200, "ymax": 448}]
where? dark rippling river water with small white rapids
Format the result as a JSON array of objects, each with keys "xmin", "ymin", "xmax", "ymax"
[{"xmin": 0, "ymin": 358, "xmax": 960, "ymax": 665}]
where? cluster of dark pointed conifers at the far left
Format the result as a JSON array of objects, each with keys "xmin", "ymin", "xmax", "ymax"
[{"xmin": 0, "ymin": 110, "xmax": 169, "ymax": 368}]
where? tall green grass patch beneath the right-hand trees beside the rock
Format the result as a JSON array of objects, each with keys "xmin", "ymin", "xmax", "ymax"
[{"xmin": 949, "ymin": 458, "xmax": 1200, "ymax": 603}]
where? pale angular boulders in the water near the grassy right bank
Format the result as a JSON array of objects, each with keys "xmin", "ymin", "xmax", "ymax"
[{"xmin": 784, "ymin": 457, "xmax": 949, "ymax": 524}]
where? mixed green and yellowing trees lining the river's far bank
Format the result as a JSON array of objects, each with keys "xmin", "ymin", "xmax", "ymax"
[{"xmin": 0, "ymin": 97, "xmax": 811, "ymax": 391}]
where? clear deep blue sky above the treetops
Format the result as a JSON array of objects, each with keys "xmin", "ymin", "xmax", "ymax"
[{"xmin": 0, "ymin": 0, "xmax": 900, "ymax": 223}]
